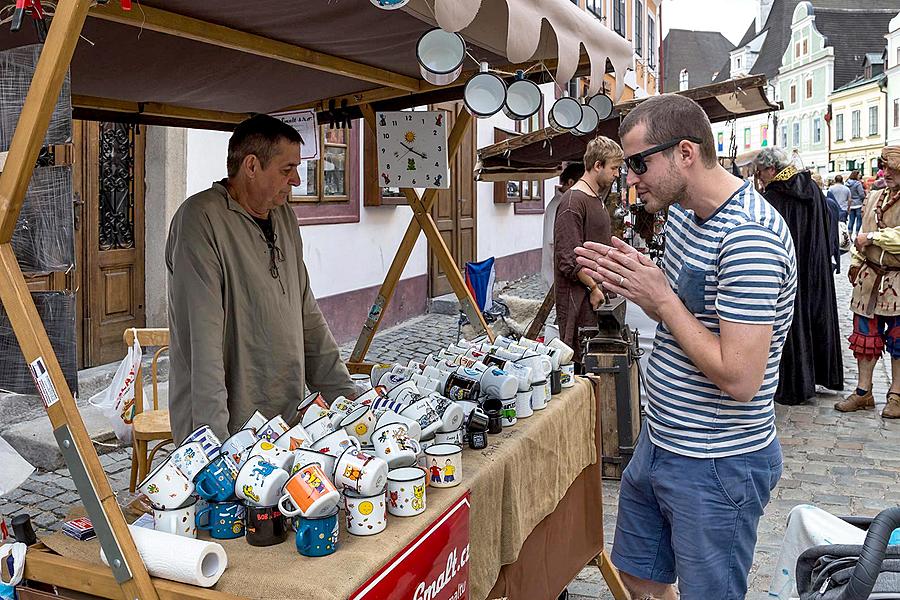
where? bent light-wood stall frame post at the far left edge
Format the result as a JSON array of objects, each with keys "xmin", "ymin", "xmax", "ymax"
[{"xmin": 0, "ymin": 0, "xmax": 158, "ymax": 600}]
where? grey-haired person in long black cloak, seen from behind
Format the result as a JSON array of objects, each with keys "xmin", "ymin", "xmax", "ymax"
[{"xmin": 755, "ymin": 147, "xmax": 844, "ymax": 404}]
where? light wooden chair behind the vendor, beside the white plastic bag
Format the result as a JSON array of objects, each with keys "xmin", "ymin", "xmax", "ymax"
[{"xmin": 123, "ymin": 328, "xmax": 173, "ymax": 493}]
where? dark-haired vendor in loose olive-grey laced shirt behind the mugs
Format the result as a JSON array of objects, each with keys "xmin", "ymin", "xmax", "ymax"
[{"xmin": 166, "ymin": 115, "xmax": 354, "ymax": 443}]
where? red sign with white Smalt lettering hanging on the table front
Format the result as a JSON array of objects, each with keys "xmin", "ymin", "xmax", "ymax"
[{"xmin": 350, "ymin": 492, "xmax": 469, "ymax": 600}]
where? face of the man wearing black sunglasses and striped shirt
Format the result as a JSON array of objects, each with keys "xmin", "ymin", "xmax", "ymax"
[{"xmin": 622, "ymin": 123, "xmax": 687, "ymax": 213}]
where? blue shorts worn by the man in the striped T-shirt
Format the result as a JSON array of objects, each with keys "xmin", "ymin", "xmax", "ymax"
[{"xmin": 612, "ymin": 425, "xmax": 782, "ymax": 600}]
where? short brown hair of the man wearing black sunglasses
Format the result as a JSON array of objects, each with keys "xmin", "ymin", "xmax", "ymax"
[{"xmin": 619, "ymin": 94, "xmax": 718, "ymax": 168}]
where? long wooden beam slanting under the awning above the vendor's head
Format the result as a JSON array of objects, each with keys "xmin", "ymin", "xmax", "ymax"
[{"xmin": 90, "ymin": 2, "xmax": 419, "ymax": 92}]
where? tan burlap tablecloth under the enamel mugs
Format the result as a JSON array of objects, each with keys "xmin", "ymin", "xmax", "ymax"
[{"xmin": 42, "ymin": 378, "xmax": 598, "ymax": 600}]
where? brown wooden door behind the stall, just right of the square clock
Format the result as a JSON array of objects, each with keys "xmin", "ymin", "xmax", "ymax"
[{"xmin": 428, "ymin": 102, "xmax": 478, "ymax": 298}]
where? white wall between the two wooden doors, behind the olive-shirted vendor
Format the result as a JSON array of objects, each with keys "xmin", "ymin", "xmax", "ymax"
[{"xmin": 187, "ymin": 127, "xmax": 428, "ymax": 298}]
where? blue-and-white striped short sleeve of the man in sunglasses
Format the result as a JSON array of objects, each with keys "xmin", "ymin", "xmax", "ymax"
[{"xmin": 716, "ymin": 222, "xmax": 791, "ymax": 325}]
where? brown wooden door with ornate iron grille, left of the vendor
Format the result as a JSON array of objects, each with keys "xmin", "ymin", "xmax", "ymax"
[{"xmin": 81, "ymin": 121, "xmax": 146, "ymax": 367}]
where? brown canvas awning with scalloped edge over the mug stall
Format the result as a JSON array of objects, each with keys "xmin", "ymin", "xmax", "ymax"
[{"xmin": 0, "ymin": 0, "xmax": 632, "ymax": 128}]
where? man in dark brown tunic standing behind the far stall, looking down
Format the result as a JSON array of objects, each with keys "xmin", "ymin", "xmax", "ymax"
[{"xmin": 553, "ymin": 136, "xmax": 624, "ymax": 362}]
